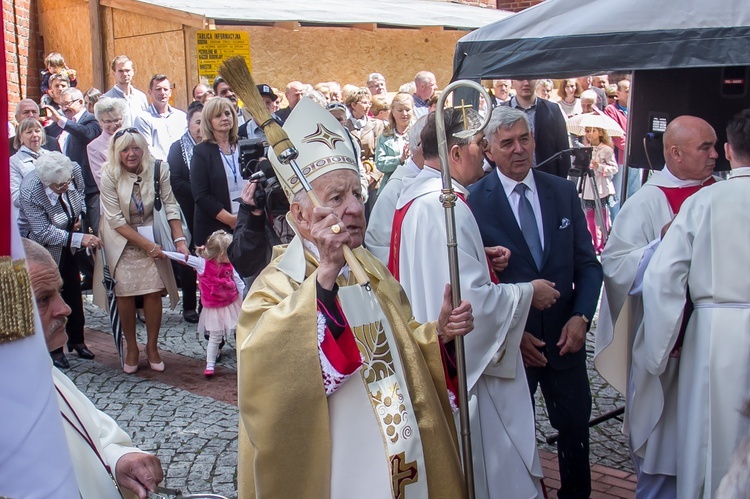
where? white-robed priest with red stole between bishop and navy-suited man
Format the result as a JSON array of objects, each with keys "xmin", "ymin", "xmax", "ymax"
[{"xmin": 389, "ymin": 109, "xmax": 559, "ymax": 499}]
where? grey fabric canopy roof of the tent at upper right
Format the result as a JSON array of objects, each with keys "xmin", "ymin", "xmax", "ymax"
[{"xmin": 453, "ymin": 0, "xmax": 750, "ymax": 80}]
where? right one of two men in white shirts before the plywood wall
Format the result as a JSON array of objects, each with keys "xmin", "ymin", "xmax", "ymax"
[{"xmin": 134, "ymin": 74, "xmax": 187, "ymax": 161}]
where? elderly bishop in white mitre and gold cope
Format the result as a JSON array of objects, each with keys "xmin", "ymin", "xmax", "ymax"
[{"xmin": 237, "ymin": 98, "xmax": 473, "ymax": 499}]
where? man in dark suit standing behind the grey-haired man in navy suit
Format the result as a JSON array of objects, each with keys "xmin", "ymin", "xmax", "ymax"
[{"xmin": 508, "ymin": 80, "xmax": 570, "ymax": 178}]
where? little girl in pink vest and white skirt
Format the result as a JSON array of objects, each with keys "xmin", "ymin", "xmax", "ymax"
[{"xmin": 187, "ymin": 230, "xmax": 245, "ymax": 378}]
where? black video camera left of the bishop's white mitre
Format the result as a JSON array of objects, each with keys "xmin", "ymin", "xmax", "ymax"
[{"xmin": 238, "ymin": 139, "xmax": 289, "ymax": 217}]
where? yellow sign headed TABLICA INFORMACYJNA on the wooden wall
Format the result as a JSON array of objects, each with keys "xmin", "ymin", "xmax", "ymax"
[{"xmin": 196, "ymin": 30, "xmax": 252, "ymax": 85}]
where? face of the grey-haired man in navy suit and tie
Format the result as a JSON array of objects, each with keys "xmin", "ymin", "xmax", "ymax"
[{"xmin": 486, "ymin": 120, "xmax": 534, "ymax": 182}]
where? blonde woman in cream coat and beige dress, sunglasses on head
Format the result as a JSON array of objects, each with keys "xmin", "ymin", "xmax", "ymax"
[{"xmin": 94, "ymin": 128, "xmax": 190, "ymax": 374}]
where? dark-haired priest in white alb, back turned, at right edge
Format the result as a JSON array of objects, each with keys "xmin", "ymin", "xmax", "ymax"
[{"xmin": 634, "ymin": 109, "xmax": 750, "ymax": 499}]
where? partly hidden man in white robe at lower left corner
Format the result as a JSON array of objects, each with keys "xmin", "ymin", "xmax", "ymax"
[{"xmin": 23, "ymin": 239, "xmax": 164, "ymax": 499}]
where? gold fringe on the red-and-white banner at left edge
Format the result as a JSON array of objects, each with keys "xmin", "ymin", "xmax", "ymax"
[{"xmin": 0, "ymin": 256, "xmax": 34, "ymax": 343}]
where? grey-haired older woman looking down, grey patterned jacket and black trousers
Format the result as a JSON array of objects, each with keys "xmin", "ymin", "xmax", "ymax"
[{"xmin": 18, "ymin": 152, "xmax": 101, "ymax": 368}]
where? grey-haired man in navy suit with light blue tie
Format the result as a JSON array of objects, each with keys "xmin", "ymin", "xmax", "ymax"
[{"xmin": 469, "ymin": 106, "xmax": 602, "ymax": 498}]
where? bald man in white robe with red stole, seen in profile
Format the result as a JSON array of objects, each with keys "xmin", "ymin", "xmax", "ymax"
[{"xmin": 594, "ymin": 116, "xmax": 718, "ymax": 498}]
